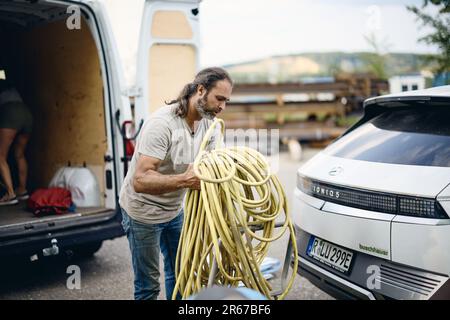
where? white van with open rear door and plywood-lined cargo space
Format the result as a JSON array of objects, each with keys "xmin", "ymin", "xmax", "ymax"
[{"xmin": 0, "ymin": 0, "xmax": 199, "ymax": 258}]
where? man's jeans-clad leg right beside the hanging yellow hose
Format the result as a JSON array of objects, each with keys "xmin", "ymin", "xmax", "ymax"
[{"xmin": 161, "ymin": 210, "xmax": 184, "ymax": 300}]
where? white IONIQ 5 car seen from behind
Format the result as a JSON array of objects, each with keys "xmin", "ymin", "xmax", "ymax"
[{"xmin": 293, "ymin": 86, "xmax": 450, "ymax": 299}]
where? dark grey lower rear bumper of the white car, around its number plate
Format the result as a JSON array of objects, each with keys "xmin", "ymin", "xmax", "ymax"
[{"xmin": 296, "ymin": 228, "xmax": 450, "ymax": 300}]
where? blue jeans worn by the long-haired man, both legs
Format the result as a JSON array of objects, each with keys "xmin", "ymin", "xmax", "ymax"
[{"xmin": 121, "ymin": 208, "xmax": 183, "ymax": 300}]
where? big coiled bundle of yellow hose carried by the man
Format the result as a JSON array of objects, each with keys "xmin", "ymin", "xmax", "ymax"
[{"xmin": 172, "ymin": 119, "xmax": 298, "ymax": 299}]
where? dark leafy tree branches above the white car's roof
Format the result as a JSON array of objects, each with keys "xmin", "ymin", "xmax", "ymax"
[{"xmin": 407, "ymin": 0, "xmax": 450, "ymax": 82}]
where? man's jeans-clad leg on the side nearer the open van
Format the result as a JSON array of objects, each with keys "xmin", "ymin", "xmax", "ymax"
[{"xmin": 122, "ymin": 209, "xmax": 161, "ymax": 300}]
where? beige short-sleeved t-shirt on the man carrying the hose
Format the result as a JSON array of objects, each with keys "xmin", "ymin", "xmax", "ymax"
[{"xmin": 119, "ymin": 104, "xmax": 220, "ymax": 224}]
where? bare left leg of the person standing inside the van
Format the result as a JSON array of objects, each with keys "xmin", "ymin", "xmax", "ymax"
[{"xmin": 0, "ymin": 128, "xmax": 17, "ymax": 200}]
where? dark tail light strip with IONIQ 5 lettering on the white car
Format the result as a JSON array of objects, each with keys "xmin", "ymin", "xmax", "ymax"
[{"xmin": 297, "ymin": 175, "xmax": 448, "ymax": 219}]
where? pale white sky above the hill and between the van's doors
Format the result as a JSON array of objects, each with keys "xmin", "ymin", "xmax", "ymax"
[{"xmin": 102, "ymin": 0, "xmax": 437, "ymax": 83}]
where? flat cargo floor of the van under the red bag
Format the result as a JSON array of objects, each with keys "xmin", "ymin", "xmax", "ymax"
[{"xmin": 0, "ymin": 201, "xmax": 110, "ymax": 227}]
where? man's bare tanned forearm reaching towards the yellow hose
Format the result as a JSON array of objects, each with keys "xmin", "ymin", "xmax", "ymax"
[{"xmin": 133, "ymin": 170, "xmax": 186, "ymax": 195}]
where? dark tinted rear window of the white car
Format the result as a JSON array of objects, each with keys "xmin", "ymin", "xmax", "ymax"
[{"xmin": 325, "ymin": 106, "xmax": 450, "ymax": 167}]
